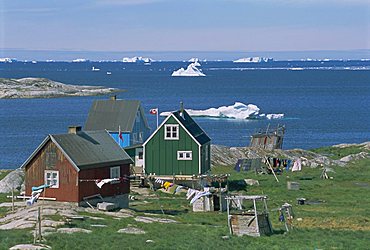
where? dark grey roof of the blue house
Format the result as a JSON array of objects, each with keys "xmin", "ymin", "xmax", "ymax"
[{"xmin": 84, "ymin": 100, "xmax": 149, "ymax": 132}]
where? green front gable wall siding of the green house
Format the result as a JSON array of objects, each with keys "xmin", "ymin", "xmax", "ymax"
[{"xmin": 145, "ymin": 117, "xmax": 199, "ymax": 175}]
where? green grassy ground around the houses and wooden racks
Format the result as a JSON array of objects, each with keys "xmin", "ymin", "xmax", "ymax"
[{"xmin": 0, "ymin": 151, "xmax": 370, "ymax": 249}]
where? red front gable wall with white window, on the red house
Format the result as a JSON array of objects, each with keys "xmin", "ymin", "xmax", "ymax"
[{"xmin": 25, "ymin": 140, "xmax": 78, "ymax": 202}]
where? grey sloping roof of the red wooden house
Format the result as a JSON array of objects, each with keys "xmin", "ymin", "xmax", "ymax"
[{"xmin": 50, "ymin": 131, "xmax": 132, "ymax": 169}]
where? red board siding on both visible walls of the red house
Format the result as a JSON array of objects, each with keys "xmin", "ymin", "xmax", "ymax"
[{"xmin": 25, "ymin": 140, "xmax": 130, "ymax": 202}]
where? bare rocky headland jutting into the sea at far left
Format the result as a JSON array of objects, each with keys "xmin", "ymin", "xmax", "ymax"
[{"xmin": 0, "ymin": 78, "xmax": 121, "ymax": 99}]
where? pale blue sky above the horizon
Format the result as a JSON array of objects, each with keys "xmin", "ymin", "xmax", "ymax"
[{"xmin": 0, "ymin": 0, "xmax": 370, "ymax": 51}]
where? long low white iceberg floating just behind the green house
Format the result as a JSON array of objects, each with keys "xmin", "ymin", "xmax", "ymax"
[{"xmin": 160, "ymin": 102, "xmax": 284, "ymax": 120}]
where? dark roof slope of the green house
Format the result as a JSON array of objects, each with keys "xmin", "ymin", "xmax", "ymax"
[{"xmin": 172, "ymin": 110, "xmax": 211, "ymax": 145}]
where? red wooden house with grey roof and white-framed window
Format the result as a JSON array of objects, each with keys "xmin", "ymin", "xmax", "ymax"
[{"xmin": 22, "ymin": 127, "xmax": 132, "ymax": 207}]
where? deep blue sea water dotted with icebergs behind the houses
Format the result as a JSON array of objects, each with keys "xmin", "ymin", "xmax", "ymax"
[{"xmin": 0, "ymin": 61, "xmax": 370, "ymax": 168}]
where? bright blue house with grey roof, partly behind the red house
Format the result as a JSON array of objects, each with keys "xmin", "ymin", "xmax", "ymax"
[{"xmin": 85, "ymin": 96, "xmax": 150, "ymax": 148}]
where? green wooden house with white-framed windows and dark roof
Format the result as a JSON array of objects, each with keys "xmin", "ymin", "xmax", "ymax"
[{"xmin": 143, "ymin": 109, "xmax": 211, "ymax": 176}]
